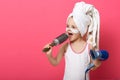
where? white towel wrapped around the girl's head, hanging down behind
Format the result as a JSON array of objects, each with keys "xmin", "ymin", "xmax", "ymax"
[{"xmin": 68, "ymin": 1, "xmax": 100, "ymax": 49}]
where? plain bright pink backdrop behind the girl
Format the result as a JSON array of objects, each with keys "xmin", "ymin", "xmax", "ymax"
[{"xmin": 0, "ymin": 0, "xmax": 120, "ymax": 80}]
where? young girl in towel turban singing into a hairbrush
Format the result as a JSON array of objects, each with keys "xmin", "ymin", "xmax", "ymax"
[{"xmin": 44, "ymin": 2, "xmax": 101, "ymax": 80}]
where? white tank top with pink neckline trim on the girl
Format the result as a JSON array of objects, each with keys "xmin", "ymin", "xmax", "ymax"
[{"xmin": 63, "ymin": 44, "xmax": 90, "ymax": 80}]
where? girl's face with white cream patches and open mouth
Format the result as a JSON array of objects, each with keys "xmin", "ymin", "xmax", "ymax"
[{"xmin": 66, "ymin": 17, "xmax": 81, "ymax": 42}]
